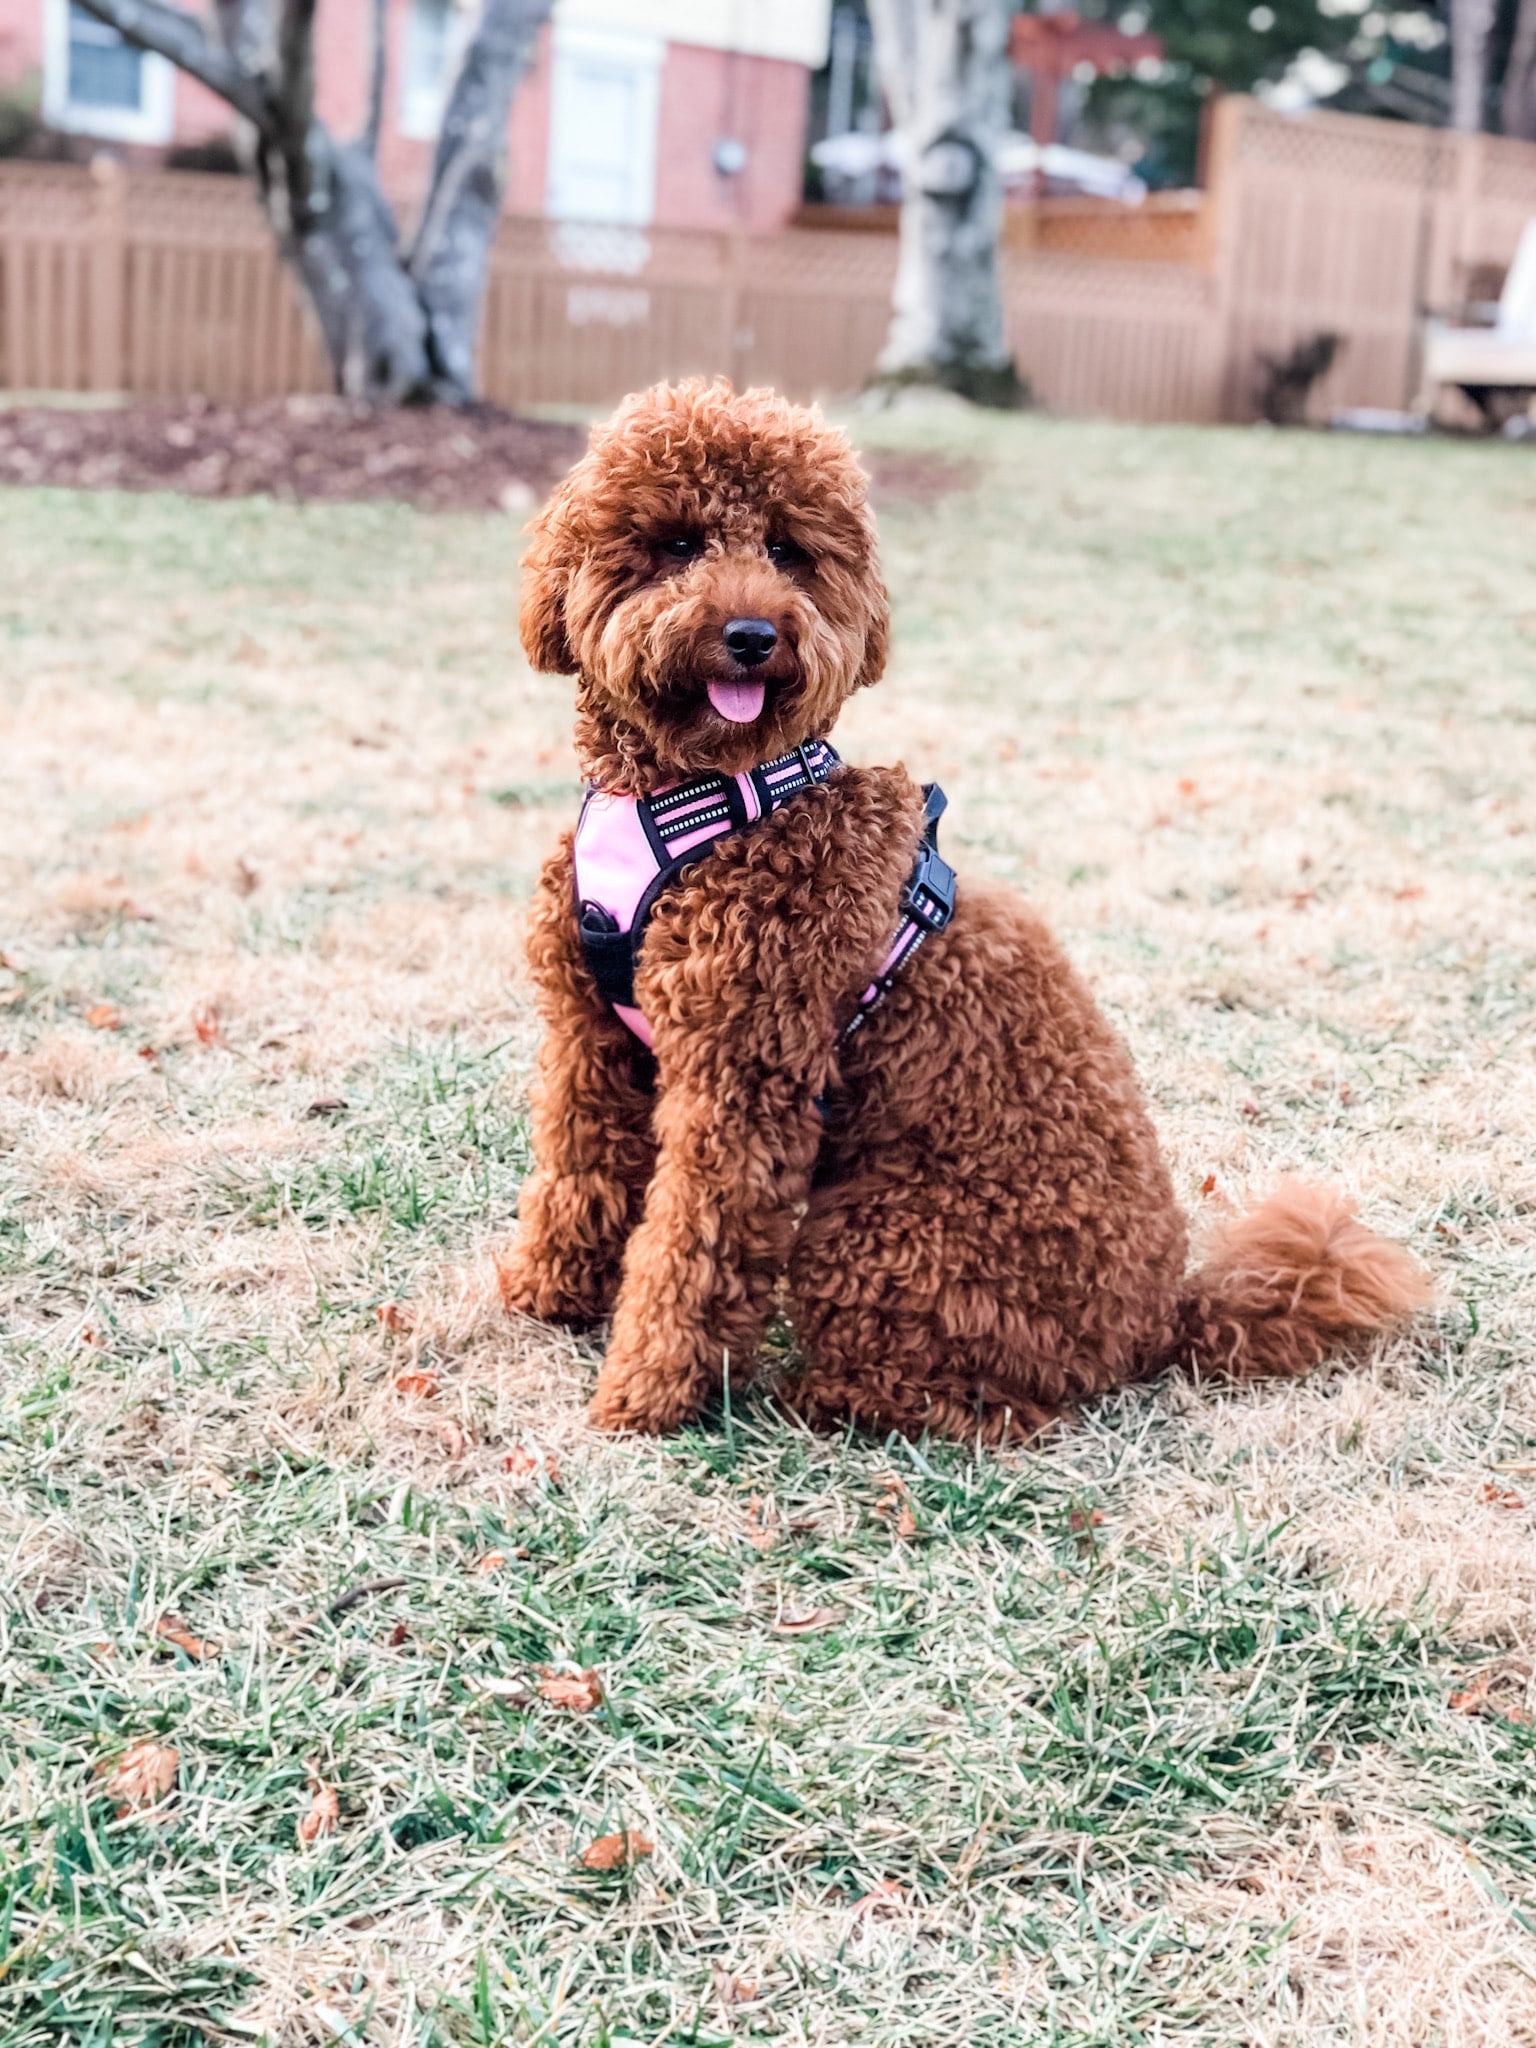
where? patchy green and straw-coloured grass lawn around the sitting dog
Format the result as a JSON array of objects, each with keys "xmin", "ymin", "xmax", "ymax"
[{"xmin": 0, "ymin": 407, "xmax": 1536, "ymax": 2048}]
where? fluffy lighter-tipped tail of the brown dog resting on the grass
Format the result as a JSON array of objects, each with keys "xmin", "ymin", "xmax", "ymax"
[{"xmin": 1143, "ymin": 1180, "xmax": 1434, "ymax": 1380}]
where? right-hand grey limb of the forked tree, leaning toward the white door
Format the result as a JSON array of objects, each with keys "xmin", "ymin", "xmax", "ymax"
[{"xmin": 408, "ymin": 0, "xmax": 553, "ymax": 391}]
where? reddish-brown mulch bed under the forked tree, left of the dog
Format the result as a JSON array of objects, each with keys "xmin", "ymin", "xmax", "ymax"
[{"xmin": 0, "ymin": 397, "xmax": 586, "ymax": 512}]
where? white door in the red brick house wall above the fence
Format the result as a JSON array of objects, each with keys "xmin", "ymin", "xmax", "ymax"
[{"xmin": 545, "ymin": 25, "xmax": 666, "ymax": 227}]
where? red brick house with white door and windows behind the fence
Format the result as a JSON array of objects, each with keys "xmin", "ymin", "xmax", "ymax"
[{"xmin": 0, "ymin": 0, "xmax": 831, "ymax": 229}]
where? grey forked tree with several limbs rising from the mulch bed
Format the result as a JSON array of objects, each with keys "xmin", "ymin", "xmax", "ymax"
[{"xmin": 82, "ymin": 0, "xmax": 553, "ymax": 403}]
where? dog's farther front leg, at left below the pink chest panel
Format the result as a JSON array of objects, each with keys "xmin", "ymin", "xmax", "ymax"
[{"xmin": 502, "ymin": 836, "xmax": 655, "ymax": 1323}]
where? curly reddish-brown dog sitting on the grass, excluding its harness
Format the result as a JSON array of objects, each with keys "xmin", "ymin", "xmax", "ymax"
[{"xmin": 502, "ymin": 383, "xmax": 1427, "ymax": 1442}]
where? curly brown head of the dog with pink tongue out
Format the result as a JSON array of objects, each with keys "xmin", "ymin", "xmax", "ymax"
[{"xmin": 522, "ymin": 379, "xmax": 887, "ymax": 795}]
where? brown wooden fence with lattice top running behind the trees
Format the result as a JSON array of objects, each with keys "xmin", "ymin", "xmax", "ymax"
[{"xmin": 0, "ymin": 98, "xmax": 1536, "ymax": 420}]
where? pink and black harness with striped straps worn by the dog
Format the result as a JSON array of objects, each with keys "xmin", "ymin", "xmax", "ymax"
[{"xmin": 575, "ymin": 739, "xmax": 954, "ymax": 1044}]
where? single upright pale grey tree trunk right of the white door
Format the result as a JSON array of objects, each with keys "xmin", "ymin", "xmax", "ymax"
[{"xmin": 870, "ymin": 0, "xmax": 1024, "ymax": 406}]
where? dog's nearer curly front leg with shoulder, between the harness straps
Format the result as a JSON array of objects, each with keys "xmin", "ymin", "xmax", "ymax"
[{"xmin": 592, "ymin": 770, "xmax": 922, "ymax": 1430}]
